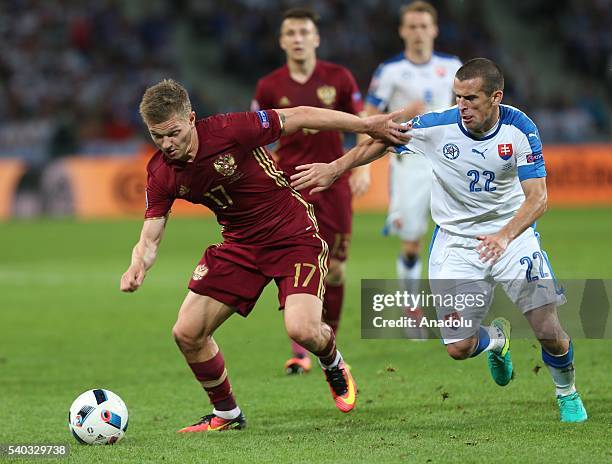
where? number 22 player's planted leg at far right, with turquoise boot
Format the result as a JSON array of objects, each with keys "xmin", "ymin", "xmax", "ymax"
[{"xmin": 525, "ymin": 304, "xmax": 588, "ymax": 422}]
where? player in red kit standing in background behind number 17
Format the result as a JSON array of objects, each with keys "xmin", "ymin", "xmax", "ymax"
[{"xmin": 251, "ymin": 8, "xmax": 370, "ymax": 374}]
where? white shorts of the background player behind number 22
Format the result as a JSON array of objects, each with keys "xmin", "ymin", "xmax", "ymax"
[{"xmin": 385, "ymin": 154, "xmax": 432, "ymax": 241}]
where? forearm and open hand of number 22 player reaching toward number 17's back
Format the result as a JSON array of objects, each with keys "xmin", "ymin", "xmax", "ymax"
[{"xmin": 291, "ymin": 138, "xmax": 389, "ymax": 193}]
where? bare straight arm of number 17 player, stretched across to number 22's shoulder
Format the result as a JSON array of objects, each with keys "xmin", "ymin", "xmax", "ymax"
[{"xmin": 274, "ymin": 106, "xmax": 409, "ymax": 145}]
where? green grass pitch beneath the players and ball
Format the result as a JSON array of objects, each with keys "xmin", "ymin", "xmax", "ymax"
[{"xmin": 0, "ymin": 209, "xmax": 612, "ymax": 463}]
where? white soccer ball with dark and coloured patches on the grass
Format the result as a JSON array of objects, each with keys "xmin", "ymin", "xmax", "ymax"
[{"xmin": 68, "ymin": 389, "xmax": 128, "ymax": 445}]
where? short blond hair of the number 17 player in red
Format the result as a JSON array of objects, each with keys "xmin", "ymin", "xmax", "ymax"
[{"xmin": 140, "ymin": 79, "xmax": 191, "ymax": 125}]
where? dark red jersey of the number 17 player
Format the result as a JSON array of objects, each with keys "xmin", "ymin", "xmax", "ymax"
[{"xmin": 145, "ymin": 111, "xmax": 316, "ymax": 244}]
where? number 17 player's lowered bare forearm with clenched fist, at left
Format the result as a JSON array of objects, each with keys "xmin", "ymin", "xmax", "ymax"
[{"xmin": 119, "ymin": 217, "xmax": 167, "ymax": 292}]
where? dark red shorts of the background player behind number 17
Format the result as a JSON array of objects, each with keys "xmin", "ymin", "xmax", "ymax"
[{"xmin": 308, "ymin": 182, "xmax": 353, "ymax": 261}]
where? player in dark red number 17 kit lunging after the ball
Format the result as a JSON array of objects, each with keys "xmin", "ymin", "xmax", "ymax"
[{"xmin": 120, "ymin": 80, "xmax": 407, "ymax": 432}]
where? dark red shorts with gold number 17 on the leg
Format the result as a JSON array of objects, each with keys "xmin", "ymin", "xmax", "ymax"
[{"xmin": 189, "ymin": 235, "xmax": 329, "ymax": 317}]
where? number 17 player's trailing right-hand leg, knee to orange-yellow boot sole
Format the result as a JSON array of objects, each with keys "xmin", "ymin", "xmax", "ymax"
[{"xmin": 285, "ymin": 293, "xmax": 357, "ymax": 412}]
